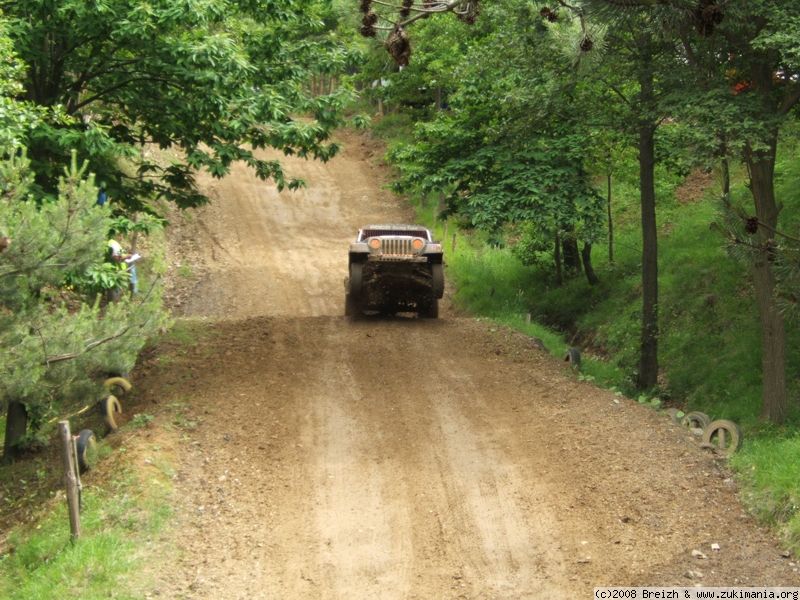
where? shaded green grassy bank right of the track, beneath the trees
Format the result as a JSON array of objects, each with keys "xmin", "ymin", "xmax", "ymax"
[{"xmin": 374, "ymin": 119, "xmax": 800, "ymax": 553}]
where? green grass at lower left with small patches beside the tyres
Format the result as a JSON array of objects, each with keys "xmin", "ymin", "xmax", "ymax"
[{"xmin": 0, "ymin": 321, "xmax": 196, "ymax": 600}]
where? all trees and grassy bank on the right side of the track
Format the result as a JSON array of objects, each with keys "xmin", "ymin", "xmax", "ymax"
[{"xmin": 360, "ymin": 0, "xmax": 800, "ymax": 549}]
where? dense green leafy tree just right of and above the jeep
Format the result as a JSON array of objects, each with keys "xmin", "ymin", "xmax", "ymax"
[{"xmin": 392, "ymin": 3, "xmax": 603, "ymax": 283}]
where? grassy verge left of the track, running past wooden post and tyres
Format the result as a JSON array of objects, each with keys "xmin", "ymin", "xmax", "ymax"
[{"xmin": 0, "ymin": 321, "xmax": 208, "ymax": 600}]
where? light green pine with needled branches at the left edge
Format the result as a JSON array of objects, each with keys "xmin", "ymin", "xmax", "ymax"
[{"xmin": 0, "ymin": 155, "xmax": 165, "ymax": 461}]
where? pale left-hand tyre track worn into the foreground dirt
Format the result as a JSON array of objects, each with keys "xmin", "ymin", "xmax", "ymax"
[{"xmin": 308, "ymin": 322, "xmax": 411, "ymax": 598}]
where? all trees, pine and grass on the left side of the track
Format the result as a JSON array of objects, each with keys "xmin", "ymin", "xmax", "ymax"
[{"xmin": 0, "ymin": 0, "xmax": 355, "ymax": 599}]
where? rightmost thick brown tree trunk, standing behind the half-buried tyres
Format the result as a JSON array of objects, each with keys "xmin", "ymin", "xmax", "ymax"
[{"xmin": 745, "ymin": 138, "xmax": 788, "ymax": 423}]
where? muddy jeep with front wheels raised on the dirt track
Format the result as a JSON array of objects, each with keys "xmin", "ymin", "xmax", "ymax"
[{"xmin": 345, "ymin": 225, "xmax": 444, "ymax": 319}]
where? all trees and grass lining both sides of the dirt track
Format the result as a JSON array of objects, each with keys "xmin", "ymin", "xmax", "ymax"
[{"xmin": 0, "ymin": 0, "xmax": 800, "ymax": 598}]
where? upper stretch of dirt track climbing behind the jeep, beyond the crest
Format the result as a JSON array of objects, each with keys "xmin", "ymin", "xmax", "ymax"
[{"xmin": 170, "ymin": 137, "xmax": 410, "ymax": 319}]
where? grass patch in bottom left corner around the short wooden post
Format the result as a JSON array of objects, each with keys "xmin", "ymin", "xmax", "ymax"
[{"xmin": 0, "ymin": 429, "xmax": 172, "ymax": 600}]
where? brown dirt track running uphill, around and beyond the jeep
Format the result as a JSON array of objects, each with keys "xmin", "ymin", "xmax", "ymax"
[{"xmin": 140, "ymin": 134, "xmax": 800, "ymax": 600}]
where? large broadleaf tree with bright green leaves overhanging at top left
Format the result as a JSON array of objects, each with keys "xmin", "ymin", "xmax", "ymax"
[{"xmin": 0, "ymin": 0, "xmax": 354, "ymax": 207}]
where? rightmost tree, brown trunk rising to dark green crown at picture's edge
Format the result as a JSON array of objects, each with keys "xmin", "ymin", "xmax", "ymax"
[{"xmin": 683, "ymin": 0, "xmax": 800, "ymax": 423}]
